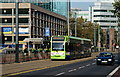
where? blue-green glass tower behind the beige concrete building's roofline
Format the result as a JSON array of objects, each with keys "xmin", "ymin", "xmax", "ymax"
[{"xmin": 0, "ymin": 0, "xmax": 68, "ymax": 17}]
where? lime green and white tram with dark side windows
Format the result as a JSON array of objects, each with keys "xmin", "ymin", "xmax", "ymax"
[{"xmin": 51, "ymin": 36, "xmax": 91, "ymax": 60}]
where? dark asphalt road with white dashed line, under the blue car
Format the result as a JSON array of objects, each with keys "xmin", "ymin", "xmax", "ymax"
[{"xmin": 9, "ymin": 53, "xmax": 120, "ymax": 77}]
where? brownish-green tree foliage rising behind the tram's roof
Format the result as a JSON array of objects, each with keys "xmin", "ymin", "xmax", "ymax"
[{"xmin": 70, "ymin": 17, "xmax": 94, "ymax": 41}]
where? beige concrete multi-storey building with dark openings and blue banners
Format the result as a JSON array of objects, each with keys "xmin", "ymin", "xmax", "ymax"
[{"xmin": 0, "ymin": 3, "xmax": 67, "ymax": 46}]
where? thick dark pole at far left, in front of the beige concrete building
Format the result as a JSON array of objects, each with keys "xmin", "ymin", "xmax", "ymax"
[{"xmin": 15, "ymin": 0, "xmax": 19, "ymax": 63}]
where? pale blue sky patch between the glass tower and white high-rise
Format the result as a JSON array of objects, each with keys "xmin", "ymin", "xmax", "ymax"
[{"xmin": 71, "ymin": 0, "xmax": 97, "ymax": 10}]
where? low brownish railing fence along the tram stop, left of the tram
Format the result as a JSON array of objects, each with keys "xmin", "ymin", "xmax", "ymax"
[{"xmin": 0, "ymin": 48, "xmax": 50, "ymax": 64}]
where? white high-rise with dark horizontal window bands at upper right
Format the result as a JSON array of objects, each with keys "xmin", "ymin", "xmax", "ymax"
[{"xmin": 89, "ymin": 0, "xmax": 118, "ymax": 30}]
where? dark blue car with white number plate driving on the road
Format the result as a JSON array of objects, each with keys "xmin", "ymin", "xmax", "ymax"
[{"xmin": 96, "ymin": 52, "xmax": 115, "ymax": 65}]
